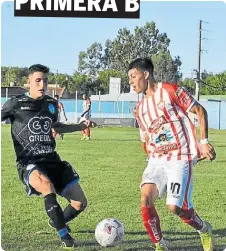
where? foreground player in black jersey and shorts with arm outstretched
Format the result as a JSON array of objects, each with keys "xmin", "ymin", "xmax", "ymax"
[{"xmin": 1, "ymin": 64, "xmax": 93, "ymax": 248}]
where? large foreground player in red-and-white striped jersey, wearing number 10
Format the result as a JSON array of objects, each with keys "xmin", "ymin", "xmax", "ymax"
[{"xmin": 128, "ymin": 58, "xmax": 216, "ymax": 251}]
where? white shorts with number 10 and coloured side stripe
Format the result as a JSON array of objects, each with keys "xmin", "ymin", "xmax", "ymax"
[{"xmin": 141, "ymin": 158, "xmax": 195, "ymax": 210}]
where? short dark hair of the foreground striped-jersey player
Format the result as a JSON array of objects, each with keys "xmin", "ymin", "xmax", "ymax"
[{"xmin": 128, "ymin": 58, "xmax": 154, "ymax": 78}]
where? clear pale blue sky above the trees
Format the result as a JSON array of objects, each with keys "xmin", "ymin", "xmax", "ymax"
[{"xmin": 1, "ymin": 1, "xmax": 226, "ymax": 77}]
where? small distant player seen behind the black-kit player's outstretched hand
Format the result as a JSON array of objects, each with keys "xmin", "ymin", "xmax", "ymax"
[{"xmin": 80, "ymin": 94, "xmax": 91, "ymax": 140}]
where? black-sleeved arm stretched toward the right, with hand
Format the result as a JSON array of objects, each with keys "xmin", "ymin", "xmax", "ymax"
[{"xmin": 52, "ymin": 120, "xmax": 97, "ymax": 133}]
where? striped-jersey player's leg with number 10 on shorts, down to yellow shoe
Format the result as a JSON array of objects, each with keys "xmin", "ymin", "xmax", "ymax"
[{"xmin": 167, "ymin": 161, "xmax": 214, "ymax": 251}]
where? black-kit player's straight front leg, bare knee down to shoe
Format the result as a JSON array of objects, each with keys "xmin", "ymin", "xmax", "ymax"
[{"xmin": 28, "ymin": 169, "xmax": 74, "ymax": 248}]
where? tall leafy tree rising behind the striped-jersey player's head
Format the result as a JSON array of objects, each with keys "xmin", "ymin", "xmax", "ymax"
[{"xmin": 78, "ymin": 22, "xmax": 181, "ymax": 91}]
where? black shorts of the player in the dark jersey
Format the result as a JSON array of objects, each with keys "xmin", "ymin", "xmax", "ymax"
[{"xmin": 17, "ymin": 159, "xmax": 79, "ymax": 196}]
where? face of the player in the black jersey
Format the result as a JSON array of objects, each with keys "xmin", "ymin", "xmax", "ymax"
[{"xmin": 28, "ymin": 72, "xmax": 48, "ymax": 99}]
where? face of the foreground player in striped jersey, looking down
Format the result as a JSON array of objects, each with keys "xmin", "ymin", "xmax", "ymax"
[{"xmin": 128, "ymin": 68, "xmax": 148, "ymax": 93}]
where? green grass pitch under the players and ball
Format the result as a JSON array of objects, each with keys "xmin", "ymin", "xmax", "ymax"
[{"xmin": 2, "ymin": 125, "xmax": 226, "ymax": 251}]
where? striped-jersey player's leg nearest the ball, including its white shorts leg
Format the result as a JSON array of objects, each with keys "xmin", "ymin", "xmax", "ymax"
[{"xmin": 141, "ymin": 160, "xmax": 168, "ymax": 250}]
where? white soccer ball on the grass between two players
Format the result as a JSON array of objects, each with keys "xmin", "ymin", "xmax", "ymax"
[{"xmin": 95, "ymin": 218, "xmax": 124, "ymax": 247}]
